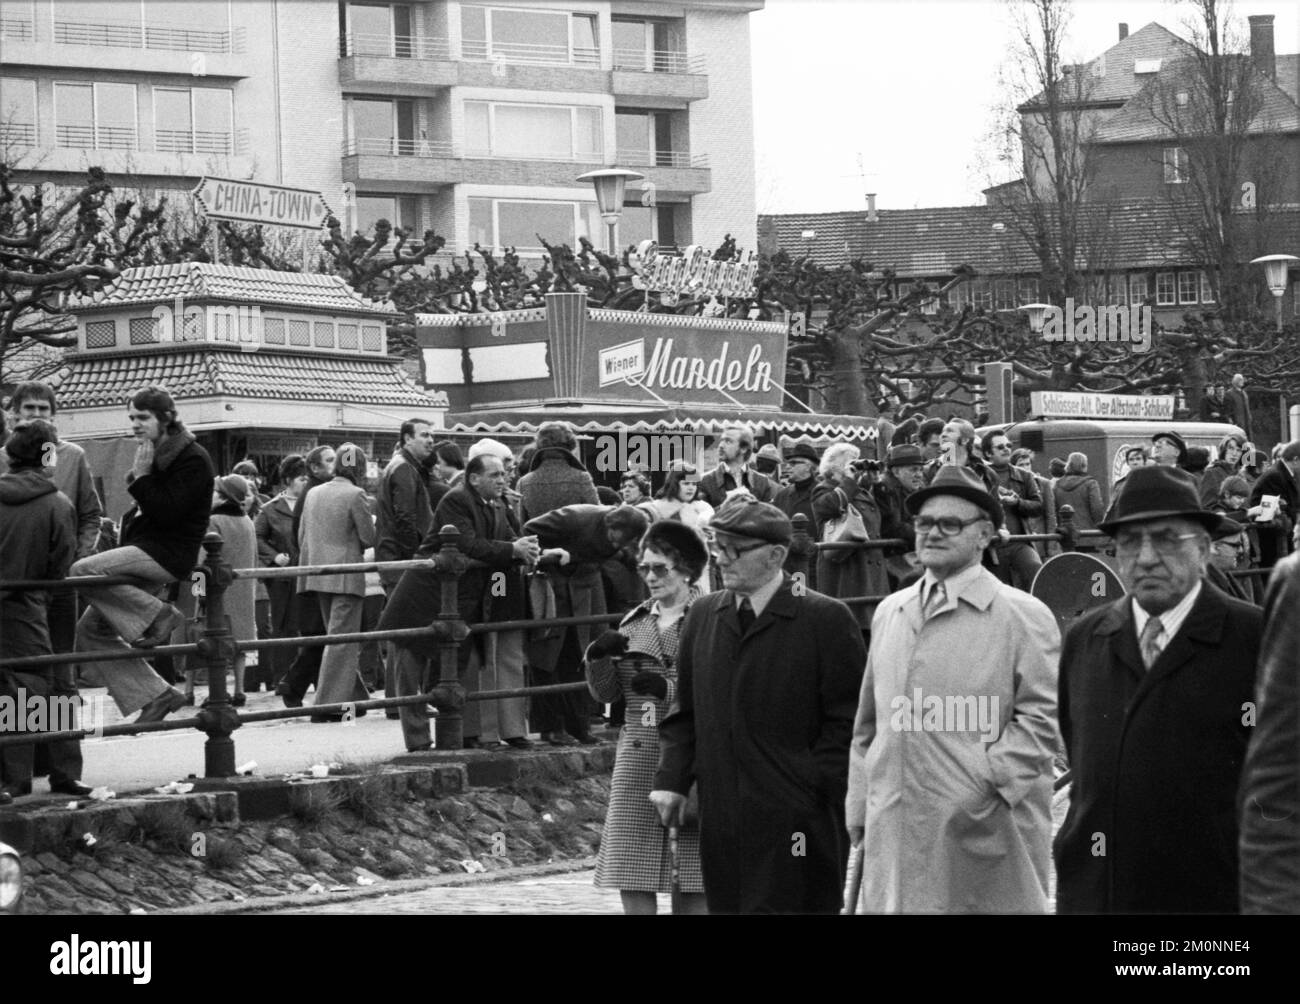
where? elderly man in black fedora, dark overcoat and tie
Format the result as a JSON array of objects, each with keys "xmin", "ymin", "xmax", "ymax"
[{"xmin": 1054, "ymin": 467, "xmax": 1262, "ymax": 913}]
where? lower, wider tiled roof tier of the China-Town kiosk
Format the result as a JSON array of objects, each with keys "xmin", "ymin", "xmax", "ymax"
[{"xmin": 59, "ymin": 349, "xmax": 447, "ymax": 408}]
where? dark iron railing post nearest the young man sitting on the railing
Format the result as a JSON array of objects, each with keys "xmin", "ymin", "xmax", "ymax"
[{"xmin": 191, "ymin": 533, "xmax": 239, "ymax": 778}]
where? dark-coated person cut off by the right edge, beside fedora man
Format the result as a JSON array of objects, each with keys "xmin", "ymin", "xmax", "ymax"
[{"xmin": 1242, "ymin": 554, "xmax": 1300, "ymax": 914}]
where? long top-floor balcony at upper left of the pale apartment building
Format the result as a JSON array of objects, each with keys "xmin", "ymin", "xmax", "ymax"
[{"xmin": 0, "ymin": 17, "xmax": 252, "ymax": 78}]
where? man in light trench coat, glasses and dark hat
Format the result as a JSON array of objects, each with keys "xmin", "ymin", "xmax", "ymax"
[{"xmin": 845, "ymin": 466, "xmax": 1061, "ymax": 913}]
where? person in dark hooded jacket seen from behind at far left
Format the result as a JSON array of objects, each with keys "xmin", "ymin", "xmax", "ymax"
[{"xmin": 0, "ymin": 420, "xmax": 77, "ymax": 805}]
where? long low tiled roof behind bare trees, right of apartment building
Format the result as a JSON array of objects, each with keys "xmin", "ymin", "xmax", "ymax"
[{"xmin": 758, "ymin": 202, "xmax": 1300, "ymax": 277}]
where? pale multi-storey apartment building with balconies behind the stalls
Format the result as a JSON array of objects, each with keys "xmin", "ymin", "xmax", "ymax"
[{"xmin": 0, "ymin": 0, "xmax": 763, "ymax": 255}]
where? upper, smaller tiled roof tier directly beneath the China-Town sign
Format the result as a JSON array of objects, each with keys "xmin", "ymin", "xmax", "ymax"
[{"xmin": 70, "ymin": 261, "xmax": 395, "ymax": 315}]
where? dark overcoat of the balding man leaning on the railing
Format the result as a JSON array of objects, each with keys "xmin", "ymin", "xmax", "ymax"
[{"xmin": 380, "ymin": 482, "xmax": 527, "ymax": 665}]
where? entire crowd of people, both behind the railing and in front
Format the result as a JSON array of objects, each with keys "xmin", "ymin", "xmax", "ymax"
[{"xmin": 0, "ymin": 384, "xmax": 1300, "ymax": 913}]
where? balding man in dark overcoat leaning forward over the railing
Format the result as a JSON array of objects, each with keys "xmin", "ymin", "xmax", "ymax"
[{"xmin": 380, "ymin": 454, "xmax": 538, "ymax": 750}]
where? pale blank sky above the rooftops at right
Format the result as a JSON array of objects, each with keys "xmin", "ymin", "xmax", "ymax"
[{"xmin": 750, "ymin": 0, "xmax": 1300, "ymax": 213}]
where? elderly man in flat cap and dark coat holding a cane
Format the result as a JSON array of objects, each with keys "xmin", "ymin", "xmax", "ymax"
[{"xmin": 650, "ymin": 498, "xmax": 866, "ymax": 913}]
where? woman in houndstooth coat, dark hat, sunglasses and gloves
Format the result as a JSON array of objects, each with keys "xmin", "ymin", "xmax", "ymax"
[{"xmin": 586, "ymin": 522, "xmax": 709, "ymax": 914}]
